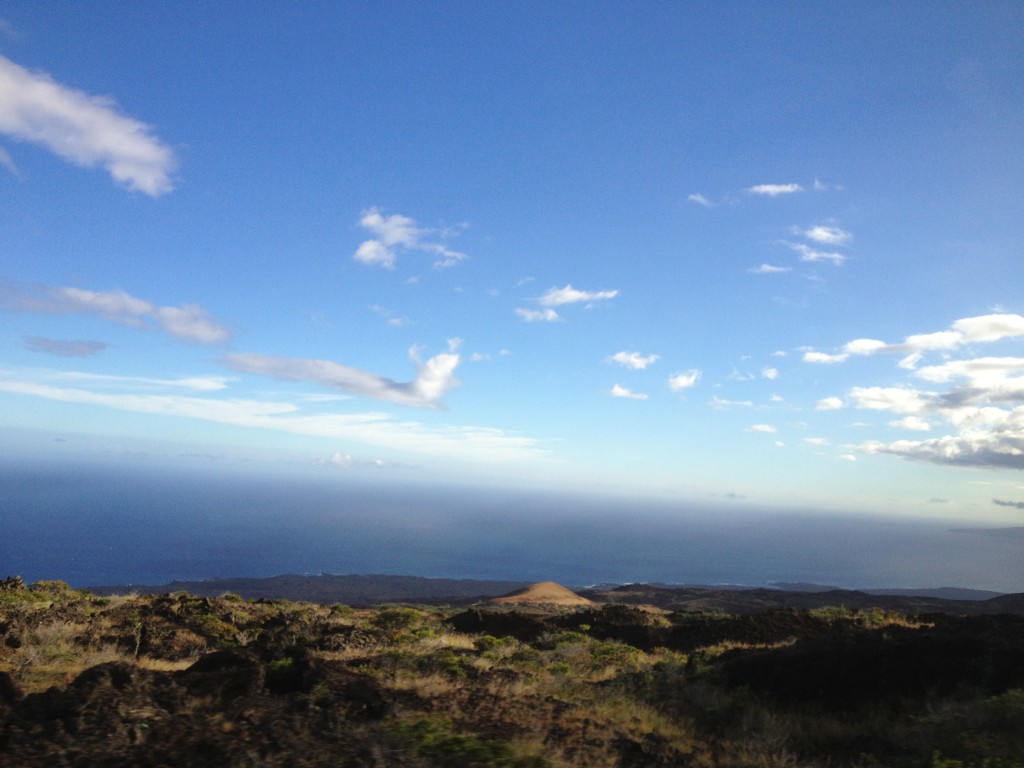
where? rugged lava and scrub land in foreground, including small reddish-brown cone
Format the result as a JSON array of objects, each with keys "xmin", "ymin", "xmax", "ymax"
[{"xmin": 0, "ymin": 579, "xmax": 1024, "ymax": 768}]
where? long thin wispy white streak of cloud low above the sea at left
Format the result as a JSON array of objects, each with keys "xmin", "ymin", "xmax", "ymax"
[{"xmin": 0, "ymin": 378, "xmax": 544, "ymax": 464}]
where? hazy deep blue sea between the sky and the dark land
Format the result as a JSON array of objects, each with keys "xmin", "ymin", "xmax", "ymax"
[{"xmin": 0, "ymin": 465, "xmax": 1024, "ymax": 592}]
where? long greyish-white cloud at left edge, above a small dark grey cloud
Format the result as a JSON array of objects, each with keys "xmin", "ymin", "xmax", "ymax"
[{"xmin": 0, "ymin": 286, "xmax": 231, "ymax": 344}]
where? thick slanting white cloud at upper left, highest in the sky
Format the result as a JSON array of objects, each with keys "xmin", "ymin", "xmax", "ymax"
[{"xmin": 0, "ymin": 56, "xmax": 176, "ymax": 197}]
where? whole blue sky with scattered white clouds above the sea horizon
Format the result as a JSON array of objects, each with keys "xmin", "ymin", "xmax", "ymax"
[{"xmin": 0, "ymin": 2, "xmax": 1024, "ymax": 524}]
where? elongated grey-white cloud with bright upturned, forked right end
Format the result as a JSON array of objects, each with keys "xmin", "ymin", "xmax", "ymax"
[{"xmin": 225, "ymin": 342, "xmax": 459, "ymax": 409}]
